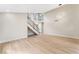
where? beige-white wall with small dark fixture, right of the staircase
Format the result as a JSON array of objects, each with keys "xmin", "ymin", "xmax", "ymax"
[{"xmin": 44, "ymin": 5, "xmax": 79, "ymax": 38}]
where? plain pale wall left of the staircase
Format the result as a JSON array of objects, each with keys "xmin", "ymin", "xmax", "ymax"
[{"xmin": 0, "ymin": 13, "xmax": 27, "ymax": 43}]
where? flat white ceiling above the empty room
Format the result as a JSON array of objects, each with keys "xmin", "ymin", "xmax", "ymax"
[{"xmin": 0, "ymin": 4, "xmax": 58, "ymax": 13}]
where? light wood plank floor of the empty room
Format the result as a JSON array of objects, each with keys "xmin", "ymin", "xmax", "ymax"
[{"xmin": 0, "ymin": 35, "xmax": 79, "ymax": 54}]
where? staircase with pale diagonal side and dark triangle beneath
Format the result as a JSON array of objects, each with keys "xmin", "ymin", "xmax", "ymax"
[{"xmin": 27, "ymin": 19, "xmax": 40, "ymax": 37}]
